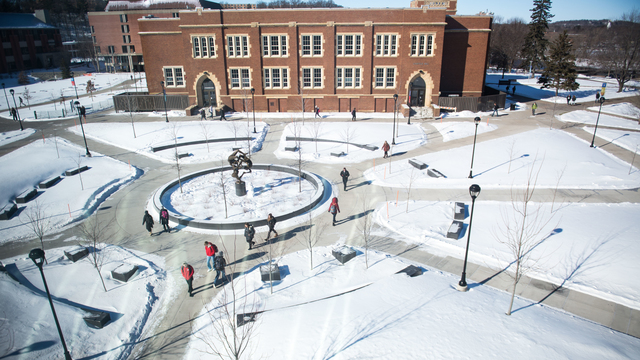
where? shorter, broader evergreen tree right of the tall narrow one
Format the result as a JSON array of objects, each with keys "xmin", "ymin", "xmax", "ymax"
[{"xmin": 538, "ymin": 30, "xmax": 580, "ymax": 96}]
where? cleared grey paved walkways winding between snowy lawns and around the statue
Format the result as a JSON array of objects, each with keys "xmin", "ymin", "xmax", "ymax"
[{"xmin": 0, "ymin": 96, "xmax": 640, "ymax": 359}]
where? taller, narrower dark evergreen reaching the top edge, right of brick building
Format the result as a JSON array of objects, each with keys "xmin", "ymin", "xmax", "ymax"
[{"xmin": 522, "ymin": 0, "xmax": 553, "ymax": 74}]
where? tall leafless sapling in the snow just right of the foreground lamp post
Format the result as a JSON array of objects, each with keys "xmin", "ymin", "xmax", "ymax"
[{"xmin": 494, "ymin": 159, "xmax": 553, "ymax": 315}]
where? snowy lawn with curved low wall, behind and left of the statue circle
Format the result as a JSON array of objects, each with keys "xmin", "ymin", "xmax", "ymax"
[{"xmin": 69, "ymin": 121, "xmax": 269, "ymax": 165}]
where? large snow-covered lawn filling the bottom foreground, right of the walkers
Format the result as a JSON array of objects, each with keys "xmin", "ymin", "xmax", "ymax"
[{"xmin": 185, "ymin": 248, "xmax": 640, "ymax": 359}]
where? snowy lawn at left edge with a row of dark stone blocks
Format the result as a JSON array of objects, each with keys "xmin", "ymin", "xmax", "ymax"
[{"xmin": 0, "ymin": 138, "xmax": 142, "ymax": 242}]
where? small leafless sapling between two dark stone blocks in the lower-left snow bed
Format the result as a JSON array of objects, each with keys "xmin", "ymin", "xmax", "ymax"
[{"xmin": 79, "ymin": 212, "xmax": 109, "ymax": 292}]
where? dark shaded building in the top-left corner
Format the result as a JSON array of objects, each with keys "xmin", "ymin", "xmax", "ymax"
[{"xmin": 0, "ymin": 10, "xmax": 63, "ymax": 73}]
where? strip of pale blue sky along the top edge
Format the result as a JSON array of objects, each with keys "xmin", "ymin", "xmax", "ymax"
[{"xmin": 225, "ymin": 0, "xmax": 640, "ymax": 22}]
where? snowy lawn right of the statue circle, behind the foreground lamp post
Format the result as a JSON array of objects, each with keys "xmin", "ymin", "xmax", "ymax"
[{"xmin": 364, "ymin": 129, "xmax": 640, "ymax": 189}]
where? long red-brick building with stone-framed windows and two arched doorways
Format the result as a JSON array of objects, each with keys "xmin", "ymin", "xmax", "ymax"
[{"xmin": 138, "ymin": 0, "xmax": 492, "ymax": 112}]
